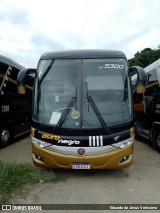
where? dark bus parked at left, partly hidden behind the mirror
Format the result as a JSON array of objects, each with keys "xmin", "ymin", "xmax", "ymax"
[{"xmin": 0, "ymin": 56, "xmax": 33, "ymax": 148}]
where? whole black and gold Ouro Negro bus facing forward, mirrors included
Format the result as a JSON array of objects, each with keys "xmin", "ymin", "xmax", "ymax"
[{"xmin": 18, "ymin": 50, "xmax": 146, "ymax": 169}]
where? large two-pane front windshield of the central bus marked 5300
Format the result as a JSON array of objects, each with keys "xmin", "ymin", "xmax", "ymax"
[{"xmin": 33, "ymin": 58, "xmax": 132, "ymax": 128}]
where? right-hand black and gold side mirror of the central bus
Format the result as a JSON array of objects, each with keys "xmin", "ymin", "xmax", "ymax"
[{"xmin": 129, "ymin": 66, "xmax": 147, "ymax": 94}]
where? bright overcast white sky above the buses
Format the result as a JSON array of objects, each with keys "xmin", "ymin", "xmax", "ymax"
[{"xmin": 0, "ymin": 0, "xmax": 160, "ymax": 67}]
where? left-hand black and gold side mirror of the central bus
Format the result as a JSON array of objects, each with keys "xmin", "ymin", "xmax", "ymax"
[{"xmin": 17, "ymin": 68, "xmax": 36, "ymax": 95}]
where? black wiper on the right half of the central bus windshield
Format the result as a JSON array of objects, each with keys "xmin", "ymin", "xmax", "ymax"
[{"xmin": 87, "ymin": 96, "xmax": 110, "ymax": 135}]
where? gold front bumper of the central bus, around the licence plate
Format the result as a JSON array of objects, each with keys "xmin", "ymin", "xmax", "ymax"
[{"xmin": 32, "ymin": 144, "xmax": 133, "ymax": 169}]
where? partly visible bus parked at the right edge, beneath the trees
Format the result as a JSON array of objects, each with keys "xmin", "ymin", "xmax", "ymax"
[{"xmin": 132, "ymin": 59, "xmax": 160, "ymax": 152}]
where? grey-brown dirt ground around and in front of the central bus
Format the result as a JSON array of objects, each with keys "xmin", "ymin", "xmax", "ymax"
[{"xmin": 0, "ymin": 137, "xmax": 160, "ymax": 213}]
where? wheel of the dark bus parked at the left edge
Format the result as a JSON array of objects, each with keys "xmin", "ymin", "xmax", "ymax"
[{"xmin": 0, "ymin": 126, "xmax": 13, "ymax": 148}]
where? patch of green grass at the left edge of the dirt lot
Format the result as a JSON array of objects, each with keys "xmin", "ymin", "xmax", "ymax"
[{"xmin": 0, "ymin": 161, "xmax": 62, "ymax": 204}]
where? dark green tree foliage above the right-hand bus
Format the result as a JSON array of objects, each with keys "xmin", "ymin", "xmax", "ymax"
[{"xmin": 128, "ymin": 48, "xmax": 160, "ymax": 68}]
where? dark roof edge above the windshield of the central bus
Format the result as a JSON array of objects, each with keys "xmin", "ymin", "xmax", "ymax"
[{"xmin": 40, "ymin": 49, "xmax": 126, "ymax": 59}]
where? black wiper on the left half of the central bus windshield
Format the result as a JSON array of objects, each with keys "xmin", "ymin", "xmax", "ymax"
[{"xmin": 54, "ymin": 97, "xmax": 77, "ymax": 133}]
